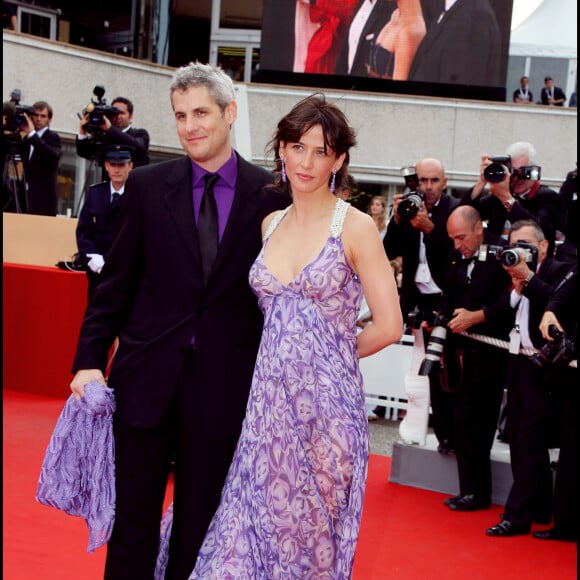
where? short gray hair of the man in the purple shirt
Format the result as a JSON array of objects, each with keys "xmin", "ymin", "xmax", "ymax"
[{"xmin": 169, "ymin": 61, "xmax": 236, "ymax": 111}]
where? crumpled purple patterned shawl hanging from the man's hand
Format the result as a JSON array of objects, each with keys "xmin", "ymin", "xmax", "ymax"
[{"xmin": 36, "ymin": 381, "xmax": 115, "ymax": 552}]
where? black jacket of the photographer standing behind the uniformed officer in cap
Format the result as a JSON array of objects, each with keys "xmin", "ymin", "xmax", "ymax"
[{"xmin": 76, "ymin": 125, "xmax": 149, "ymax": 167}]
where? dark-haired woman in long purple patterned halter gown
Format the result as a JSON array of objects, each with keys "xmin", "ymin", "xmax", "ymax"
[{"xmin": 191, "ymin": 95, "xmax": 402, "ymax": 580}]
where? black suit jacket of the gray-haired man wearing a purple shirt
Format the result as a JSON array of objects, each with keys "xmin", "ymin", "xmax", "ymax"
[{"xmin": 73, "ymin": 157, "xmax": 288, "ymax": 433}]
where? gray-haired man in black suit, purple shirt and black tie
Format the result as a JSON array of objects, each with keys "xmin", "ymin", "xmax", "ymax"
[{"xmin": 71, "ymin": 63, "xmax": 289, "ymax": 580}]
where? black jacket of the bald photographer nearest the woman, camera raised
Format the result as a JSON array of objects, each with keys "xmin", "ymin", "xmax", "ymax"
[{"xmin": 383, "ymin": 194, "xmax": 459, "ymax": 319}]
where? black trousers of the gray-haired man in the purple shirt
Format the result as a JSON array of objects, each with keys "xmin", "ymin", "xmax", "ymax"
[{"xmin": 105, "ymin": 351, "xmax": 241, "ymax": 580}]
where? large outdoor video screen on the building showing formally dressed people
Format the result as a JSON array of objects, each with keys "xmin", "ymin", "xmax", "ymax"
[{"xmin": 254, "ymin": 0, "xmax": 513, "ymax": 101}]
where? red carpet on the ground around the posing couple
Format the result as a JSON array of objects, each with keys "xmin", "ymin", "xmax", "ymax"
[{"xmin": 3, "ymin": 390, "xmax": 577, "ymax": 580}]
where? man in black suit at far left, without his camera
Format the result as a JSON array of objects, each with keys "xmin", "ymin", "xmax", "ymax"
[{"xmin": 20, "ymin": 101, "xmax": 61, "ymax": 216}]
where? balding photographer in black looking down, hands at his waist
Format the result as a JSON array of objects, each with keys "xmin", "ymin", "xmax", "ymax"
[{"xmin": 438, "ymin": 206, "xmax": 513, "ymax": 511}]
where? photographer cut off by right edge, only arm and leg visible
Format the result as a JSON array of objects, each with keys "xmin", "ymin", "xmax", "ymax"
[{"xmin": 533, "ymin": 266, "xmax": 580, "ymax": 542}]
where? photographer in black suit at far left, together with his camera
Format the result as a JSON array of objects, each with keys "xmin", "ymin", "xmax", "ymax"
[{"xmin": 4, "ymin": 101, "xmax": 61, "ymax": 216}]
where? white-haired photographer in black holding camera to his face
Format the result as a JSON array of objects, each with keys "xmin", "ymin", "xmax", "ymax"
[{"xmin": 462, "ymin": 141, "xmax": 562, "ymax": 257}]
